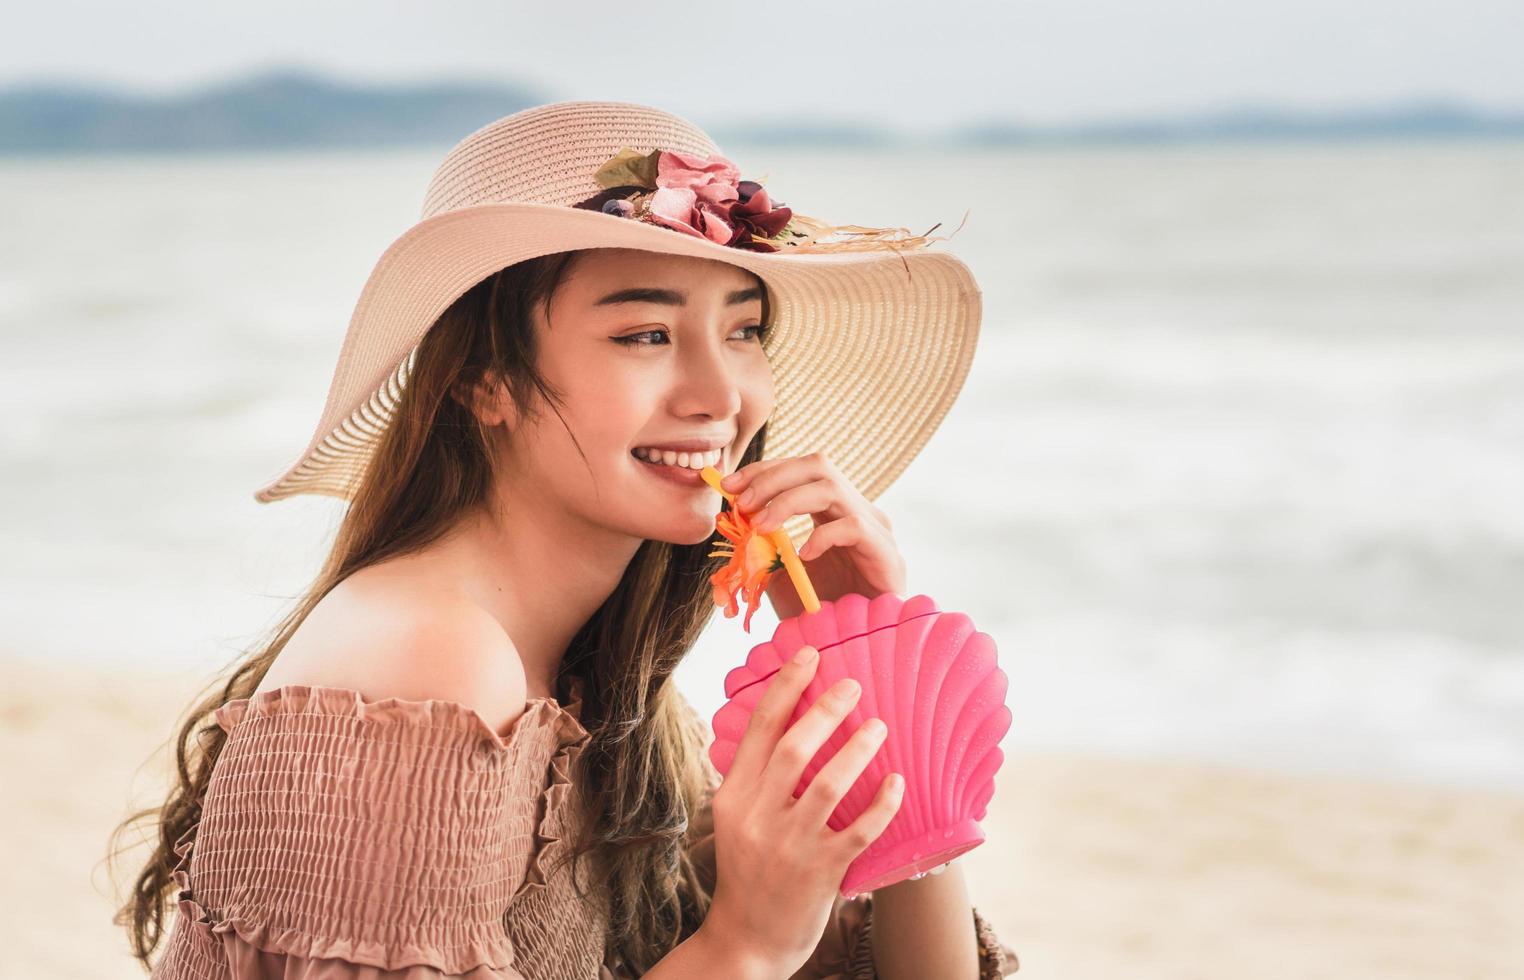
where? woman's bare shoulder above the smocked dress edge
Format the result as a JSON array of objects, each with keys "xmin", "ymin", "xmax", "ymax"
[{"xmin": 259, "ymin": 567, "xmax": 529, "ymax": 732}]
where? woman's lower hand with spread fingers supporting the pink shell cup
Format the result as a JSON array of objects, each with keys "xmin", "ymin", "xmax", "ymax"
[{"xmin": 701, "ymin": 646, "xmax": 904, "ymax": 975}]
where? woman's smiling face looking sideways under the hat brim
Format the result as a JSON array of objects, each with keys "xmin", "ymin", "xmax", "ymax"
[{"xmin": 501, "ymin": 248, "xmax": 773, "ymax": 544}]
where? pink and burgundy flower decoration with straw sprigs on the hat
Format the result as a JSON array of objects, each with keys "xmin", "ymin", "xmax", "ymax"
[{"xmin": 573, "ymin": 148, "xmax": 968, "ymax": 251}]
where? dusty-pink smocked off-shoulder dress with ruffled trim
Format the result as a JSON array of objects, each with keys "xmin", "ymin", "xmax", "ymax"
[{"xmin": 152, "ymin": 684, "xmax": 1017, "ymax": 980}]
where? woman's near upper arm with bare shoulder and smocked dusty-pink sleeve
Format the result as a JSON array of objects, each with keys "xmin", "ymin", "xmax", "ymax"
[{"xmin": 174, "ymin": 593, "xmax": 549, "ymax": 980}]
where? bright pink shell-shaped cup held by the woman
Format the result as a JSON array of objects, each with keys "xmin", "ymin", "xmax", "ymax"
[{"xmin": 709, "ymin": 593, "xmax": 1010, "ymax": 898}]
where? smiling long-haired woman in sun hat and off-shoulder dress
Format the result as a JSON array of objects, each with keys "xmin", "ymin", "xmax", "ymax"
[{"xmin": 117, "ymin": 102, "xmax": 1015, "ymax": 980}]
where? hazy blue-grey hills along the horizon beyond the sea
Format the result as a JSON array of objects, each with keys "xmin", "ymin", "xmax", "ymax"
[{"xmin": 0, "ymin": 70, "xmax": 1524, "ymax": 154}]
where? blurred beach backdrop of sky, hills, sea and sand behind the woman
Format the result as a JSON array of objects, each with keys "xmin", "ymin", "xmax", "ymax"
[{"xmin": 0, "ymin": 0, "xmax": 1524, "ymax": 978}]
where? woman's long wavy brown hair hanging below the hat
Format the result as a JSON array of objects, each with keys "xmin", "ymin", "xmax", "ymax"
[{"xmin": 108, "ymin": 251, "xmax": 771, "ymax": 972}]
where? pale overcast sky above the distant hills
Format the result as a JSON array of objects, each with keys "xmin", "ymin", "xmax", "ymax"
[{"xmin": 0, "ymin": 0, "xmax": 1524, "ymax": 128}]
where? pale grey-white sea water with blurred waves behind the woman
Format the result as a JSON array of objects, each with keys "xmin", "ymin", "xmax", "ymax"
[{"xmin": 0, "ymin": 143, "xmax": 1524, "ymax": 789}]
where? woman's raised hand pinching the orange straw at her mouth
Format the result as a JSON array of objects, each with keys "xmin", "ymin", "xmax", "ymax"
[{"xmin": 721, "ymin": 453, "xmax": 905, "ymax": 619}]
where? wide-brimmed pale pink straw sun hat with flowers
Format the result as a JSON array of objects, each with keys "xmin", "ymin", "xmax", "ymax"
[{"xmin": 255, "ymin": 102, "xmax": 980, "ymax": 546}]
